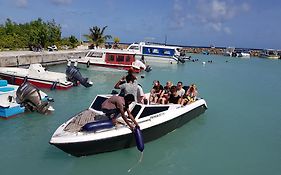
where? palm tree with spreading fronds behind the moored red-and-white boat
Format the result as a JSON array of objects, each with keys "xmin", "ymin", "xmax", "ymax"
[{"xmin": 84, "ymin": 26, "xmax": 112, "ymax": 47}]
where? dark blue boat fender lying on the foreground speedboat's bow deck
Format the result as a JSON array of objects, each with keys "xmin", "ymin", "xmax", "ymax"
[{"xmin": 82, "ymin": 120, "xmax": 114, "ymax": 132}]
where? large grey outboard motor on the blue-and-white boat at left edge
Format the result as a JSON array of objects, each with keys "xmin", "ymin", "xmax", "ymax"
[{"xmin": 16, "ymin": 81, "xmax": 53, "ymax": 114}]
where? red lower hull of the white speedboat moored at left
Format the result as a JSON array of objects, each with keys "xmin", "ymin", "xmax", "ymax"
[{"xmin": 0, "ymin": 73, "xmax": 72, "ymax": 90}]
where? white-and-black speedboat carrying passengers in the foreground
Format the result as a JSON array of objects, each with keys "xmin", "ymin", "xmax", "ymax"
[{"xmin": 50, "ymin": 95, "xmax": 207, "ymax": 156}]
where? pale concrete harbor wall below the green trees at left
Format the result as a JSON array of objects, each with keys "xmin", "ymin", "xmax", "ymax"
[{"xmin": 0, "ymin": 50, "xmax": 87, "ymax": 67}]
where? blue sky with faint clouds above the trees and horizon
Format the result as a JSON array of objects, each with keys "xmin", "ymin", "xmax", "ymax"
[{"xmin": 0, "ymin": 0, "xmax": 281, "ymax": 49}]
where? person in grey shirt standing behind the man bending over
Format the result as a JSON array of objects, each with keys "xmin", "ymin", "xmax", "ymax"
[{"xmin": 114, "ymin": 74, "xmax": 138, "ymax": 101}]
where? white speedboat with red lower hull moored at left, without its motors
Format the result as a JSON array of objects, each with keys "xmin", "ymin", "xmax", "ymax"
[{"xmin": 0, "ymin": 64, "xmax": 73, "ymax": 89}]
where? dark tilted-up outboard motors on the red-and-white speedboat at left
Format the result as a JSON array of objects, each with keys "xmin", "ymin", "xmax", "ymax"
[{"xmin": 65, "ymin": 61, "xmax": 93, "ymax": 87}]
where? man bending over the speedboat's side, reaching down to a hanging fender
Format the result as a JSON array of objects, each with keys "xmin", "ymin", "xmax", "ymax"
[{"xmin": 101, "ymin": 94, "xmax": 139, "ymax": 130}]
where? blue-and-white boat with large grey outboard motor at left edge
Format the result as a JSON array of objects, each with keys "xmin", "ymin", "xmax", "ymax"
[{"xmin": 0, "ymin": 80, "xmax": 54, "ymax": 118}]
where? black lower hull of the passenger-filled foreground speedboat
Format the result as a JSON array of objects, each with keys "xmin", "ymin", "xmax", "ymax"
[{"xmin": 50, "ymin": 105, "xmax": 207, "ymax": 157}]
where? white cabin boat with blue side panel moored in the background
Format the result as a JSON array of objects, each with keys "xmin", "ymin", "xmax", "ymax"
[{"xmin": 127, "ymin": 42, "xmax": 187, "ymax": 63}]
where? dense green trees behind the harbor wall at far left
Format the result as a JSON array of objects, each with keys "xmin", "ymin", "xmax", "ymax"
[{"xmin": 0, "ymin": 18, "xmax": 61, "ymax": 49}]
